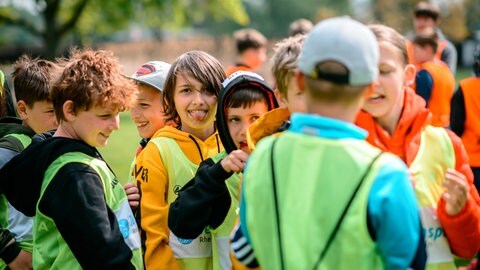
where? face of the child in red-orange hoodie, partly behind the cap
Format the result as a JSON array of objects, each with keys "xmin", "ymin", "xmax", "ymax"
[{"xmin": 363, "ymin": 42, "xmax": 415, "ymax": 127}]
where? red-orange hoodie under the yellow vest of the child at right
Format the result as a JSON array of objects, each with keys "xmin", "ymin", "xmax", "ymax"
[{"xmin": 356, "ymin": 89, "xmax": 480, "ymax": 258}]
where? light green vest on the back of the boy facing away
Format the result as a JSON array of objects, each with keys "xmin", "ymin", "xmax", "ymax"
[{"xmin": 243, "ymin": 135, "xmax": 384, "ymax": 269}]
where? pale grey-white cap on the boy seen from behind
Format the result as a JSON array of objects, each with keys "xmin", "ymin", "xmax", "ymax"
[{"xmin": 298, "ymin": 16, "xmax": 379, "ymax": 86}]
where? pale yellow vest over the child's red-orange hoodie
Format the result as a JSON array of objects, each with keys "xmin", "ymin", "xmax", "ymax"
[{"xmin": 410, "ymin": 126, "xmax": 456, "ymax": 270}]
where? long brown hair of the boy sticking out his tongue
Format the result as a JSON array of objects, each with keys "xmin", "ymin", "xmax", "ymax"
[{"xmin": 163, "ymin": 51, "xmax": 226, "ymax": 125}]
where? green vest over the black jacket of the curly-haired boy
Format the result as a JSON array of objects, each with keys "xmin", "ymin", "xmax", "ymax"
[{"xmin": 33, "ymin": 152, "xmax": 143, "ymax": 270}]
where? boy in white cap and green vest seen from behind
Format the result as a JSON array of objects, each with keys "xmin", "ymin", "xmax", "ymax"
[{"xmin": 232, "ymin": 17, "xmax": 424, "ymax": 269}]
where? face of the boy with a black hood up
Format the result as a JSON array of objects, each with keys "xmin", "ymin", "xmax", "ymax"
[{"xmin": 227, "ymin": 101, "xmax": 268, "ymax": 153}]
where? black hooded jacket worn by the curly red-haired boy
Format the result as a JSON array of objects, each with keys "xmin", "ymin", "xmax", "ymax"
[{"xmin": 0, "ymin": 134, "xmax": 134, "ymax": 269}]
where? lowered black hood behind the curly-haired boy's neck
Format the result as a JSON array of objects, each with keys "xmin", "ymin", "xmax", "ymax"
[{"xmin": 0, "ymin": 132, "xmax": 100, "ymax": 216}]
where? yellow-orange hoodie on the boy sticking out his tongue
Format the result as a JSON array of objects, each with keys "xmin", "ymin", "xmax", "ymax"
[{"xmin": 135, "ymin": 126, "xmax": 223, "ymax": 270}]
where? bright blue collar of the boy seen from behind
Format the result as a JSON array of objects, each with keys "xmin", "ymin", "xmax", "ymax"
[{"xmin": 289, "ymin": 113, "xmax": 368, "ymax": 140}]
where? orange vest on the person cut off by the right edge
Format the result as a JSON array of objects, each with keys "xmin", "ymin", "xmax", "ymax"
[{"xmin": 460, "ymin": 78, "xmax": 480, "ymax": 167}]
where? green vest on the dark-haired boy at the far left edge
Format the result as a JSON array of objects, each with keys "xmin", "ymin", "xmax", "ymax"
[{"xmin": 0, "ymin": 133, "xmax": 33, "ymax": 269}]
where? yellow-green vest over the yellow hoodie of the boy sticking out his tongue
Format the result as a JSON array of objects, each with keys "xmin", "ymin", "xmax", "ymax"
[{"xmin": 150, "ymin": 137, "xmax": 212, "ymax": 270}]
